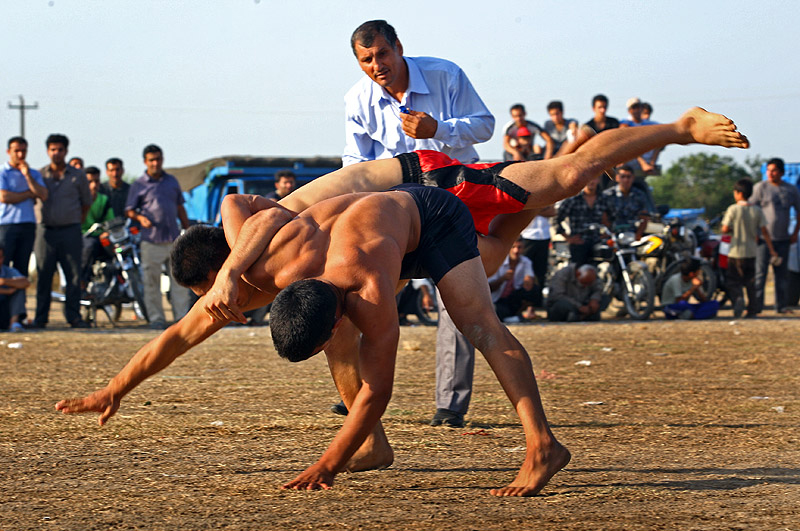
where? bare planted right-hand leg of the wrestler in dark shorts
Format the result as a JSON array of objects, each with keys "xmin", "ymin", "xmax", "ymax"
[{"xmin": 439, "ymin": 258, "xmax": 570, "ymax": 496}]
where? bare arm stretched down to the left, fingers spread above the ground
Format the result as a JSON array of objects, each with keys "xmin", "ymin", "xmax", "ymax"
[{"xmin": 56, "ymin": 304, "xmax": 227, "ymax": 426}]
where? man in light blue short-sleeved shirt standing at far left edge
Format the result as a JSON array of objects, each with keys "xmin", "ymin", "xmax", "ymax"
[{"xmin": 0, "ymin": 136, "xmax": 47, "ymax": 323}]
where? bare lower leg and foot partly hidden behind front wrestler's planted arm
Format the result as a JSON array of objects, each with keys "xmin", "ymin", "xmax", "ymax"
[{"xmin": 325, "ymin": 317, "xmax": 394, "ymax": 472}]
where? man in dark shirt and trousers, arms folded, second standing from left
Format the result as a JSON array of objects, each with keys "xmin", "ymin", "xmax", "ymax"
[{"xmin": 33, "ymin": 134, "xmax": 92, "ymax": 328}]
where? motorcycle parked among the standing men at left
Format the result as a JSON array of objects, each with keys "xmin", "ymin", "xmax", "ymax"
[{"xmin": 81, "ymin": 219, "xmax": 147, "ymax": 325}]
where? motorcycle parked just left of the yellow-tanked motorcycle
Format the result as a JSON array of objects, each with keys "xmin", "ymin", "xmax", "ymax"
[{"xmin": 588, "ymin": 223, "xmax": 656, "ymax": 320}]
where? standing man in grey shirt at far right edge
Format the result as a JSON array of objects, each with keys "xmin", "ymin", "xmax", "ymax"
[{"xmin": 750, "ymin": 158, "xmax": 800, "ymax": 313}]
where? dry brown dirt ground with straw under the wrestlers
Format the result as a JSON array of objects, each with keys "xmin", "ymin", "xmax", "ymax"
[{"xmin": 0, "ymin": 302, "xmax": 800, "ymax": 531}]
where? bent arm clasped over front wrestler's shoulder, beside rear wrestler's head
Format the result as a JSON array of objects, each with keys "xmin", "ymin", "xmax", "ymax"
[{"xmin": 203, "ymin": 194, "xmax": 296, "ymax": 323}]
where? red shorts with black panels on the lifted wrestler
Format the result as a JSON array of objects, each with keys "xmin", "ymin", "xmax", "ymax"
[{"xmin": 396, "ymin": 150, "xmax": 530, "ymax": 234}]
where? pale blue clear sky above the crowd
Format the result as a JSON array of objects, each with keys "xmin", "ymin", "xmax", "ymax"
[{"xmin": 0, "ymin": 0, "xmax": 800, "ymax": 181}]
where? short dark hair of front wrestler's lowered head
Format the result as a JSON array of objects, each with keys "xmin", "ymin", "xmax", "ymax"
[{"xmin": 269, "ymin": 279, "xmax": 339, "ymax": 362}]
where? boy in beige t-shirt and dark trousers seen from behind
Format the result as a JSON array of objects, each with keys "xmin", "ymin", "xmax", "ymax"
[{"xmin": 722, "ymin": 179, "xmax": 780, "ymax": 318}]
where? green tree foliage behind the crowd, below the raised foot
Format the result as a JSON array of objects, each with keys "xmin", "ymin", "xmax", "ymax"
[{"xmin": 647, "ymin": 153, "xmax": 761, "ymax": 219}]
